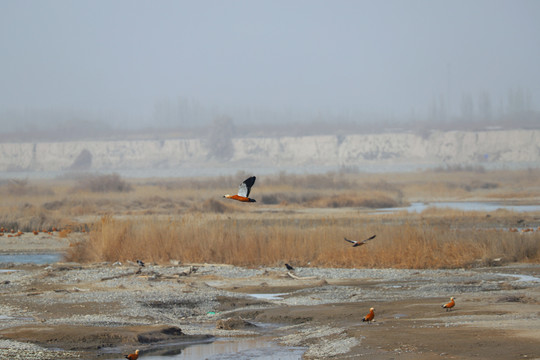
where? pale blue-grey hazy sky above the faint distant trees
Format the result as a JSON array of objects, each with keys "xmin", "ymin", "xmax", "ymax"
[{"xmin": 0, "ymin": 0, "xmax": 540, "ymax": 127}]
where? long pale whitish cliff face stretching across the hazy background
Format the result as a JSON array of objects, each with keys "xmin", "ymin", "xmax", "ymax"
[{"xmin": 0, "ymin": 130, "xmax": 540, "ymax": 171}]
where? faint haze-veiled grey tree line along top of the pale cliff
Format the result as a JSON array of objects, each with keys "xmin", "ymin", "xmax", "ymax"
[{"xmin": 0, "ymin": 88, "xmax": 540, "ymax": 143}]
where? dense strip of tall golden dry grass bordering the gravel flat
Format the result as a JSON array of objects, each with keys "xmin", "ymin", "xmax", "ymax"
[{"xmin": 67, "ymin": 214, "xmax": 540, "ymax": 269}]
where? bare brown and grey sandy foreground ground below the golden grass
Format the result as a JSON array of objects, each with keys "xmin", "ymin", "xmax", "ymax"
[{"xmin": 0, "ymin": 235, "xmax": 540, "ymax": 360}]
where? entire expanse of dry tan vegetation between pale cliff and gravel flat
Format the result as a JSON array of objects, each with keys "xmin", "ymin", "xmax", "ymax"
[{"xmin": 0, "ymin": 169, "xmax": 540, "ymax": 268}]
